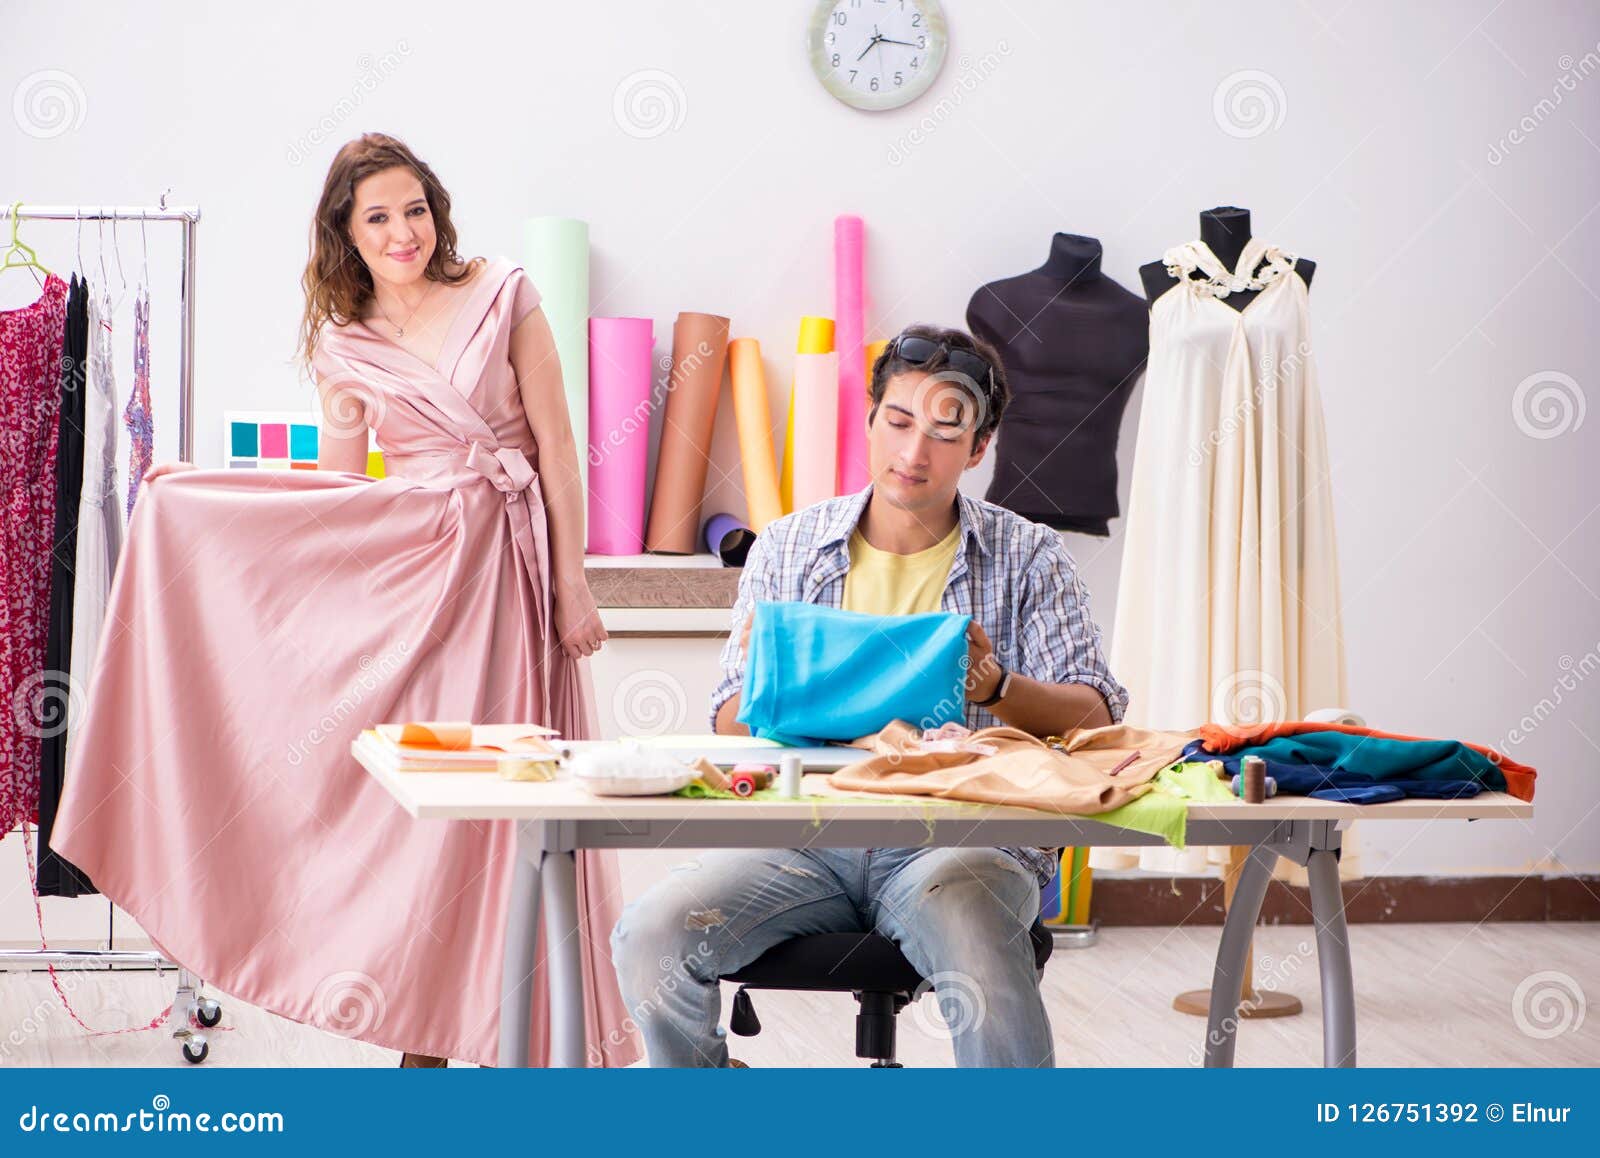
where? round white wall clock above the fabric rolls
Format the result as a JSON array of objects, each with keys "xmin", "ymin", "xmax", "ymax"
[{"xmin": 808, "ymin": 0, "xmax": 949, "ymax": 110}]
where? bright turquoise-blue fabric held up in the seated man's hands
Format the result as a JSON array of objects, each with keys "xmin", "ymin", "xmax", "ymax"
[{"xmin": 739, "ymin": 603, "xmax": 971, "ymax": 745}]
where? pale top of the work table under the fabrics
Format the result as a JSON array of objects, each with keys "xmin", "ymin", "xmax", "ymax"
[{"xmin": 350, "ymin": 742, "xmax": 1533, "ymax": 824}]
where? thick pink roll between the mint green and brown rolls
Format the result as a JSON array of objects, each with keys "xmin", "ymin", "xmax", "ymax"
[{"xmin": 589, "ymin": 318, "xmax": 654, "ymax": 555}]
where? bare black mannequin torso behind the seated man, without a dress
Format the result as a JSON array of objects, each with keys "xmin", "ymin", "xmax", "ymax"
[{"xmin": 966, "ymin": 234, "xmax": 1150, "ymax": 534}]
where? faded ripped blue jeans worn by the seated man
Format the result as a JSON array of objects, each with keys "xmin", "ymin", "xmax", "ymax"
[{"xmin": 611, "ymin": 848, "xmax": 1056, "ymax": 1068}]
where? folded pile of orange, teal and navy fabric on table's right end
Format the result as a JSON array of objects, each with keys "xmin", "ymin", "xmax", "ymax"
[{"xmin": 1184, "ymin": 720, "xmax": 1538, "ymax": 805}]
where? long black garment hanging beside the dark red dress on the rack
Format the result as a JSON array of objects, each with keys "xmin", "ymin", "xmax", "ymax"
[{"xmin": 35, "ymin": 274, "xmax": 99, "ymax": 897}]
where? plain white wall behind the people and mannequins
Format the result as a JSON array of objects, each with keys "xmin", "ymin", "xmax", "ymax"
[{"xmin": 0, "ymin": 0, "xmax": 1600, "ymax": 872}]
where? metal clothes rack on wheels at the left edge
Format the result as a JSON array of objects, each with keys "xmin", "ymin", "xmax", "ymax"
[{"xmin": 0, "ymin": 195, "xmax": 222, "ymax": 1062}]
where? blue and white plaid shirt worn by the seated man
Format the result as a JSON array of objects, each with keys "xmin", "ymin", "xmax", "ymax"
[{"xmin": 710, "ymin": 486, "xmax": 1128, "ymax": 884}]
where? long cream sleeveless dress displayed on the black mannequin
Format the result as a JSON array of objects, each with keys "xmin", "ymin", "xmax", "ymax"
[{"xmin": 1096, "ymin": 238, "xmax": 1347, "ymax": 872}]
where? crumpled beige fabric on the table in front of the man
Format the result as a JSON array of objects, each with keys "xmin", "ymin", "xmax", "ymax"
[{"xmin": 829, "ymin": 720, "xmax": 1197, "ymax": 816}]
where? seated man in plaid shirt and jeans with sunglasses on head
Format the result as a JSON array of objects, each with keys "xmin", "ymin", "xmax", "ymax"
[{"xmin": 611, "ymin": 326, "xmax": 1126, "ymax": 1067}]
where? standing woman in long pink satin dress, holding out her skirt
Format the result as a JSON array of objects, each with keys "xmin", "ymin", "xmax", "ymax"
[{"xmin": 53, "ymin": 133, "xmax": 638, "ymax": 1065}]
